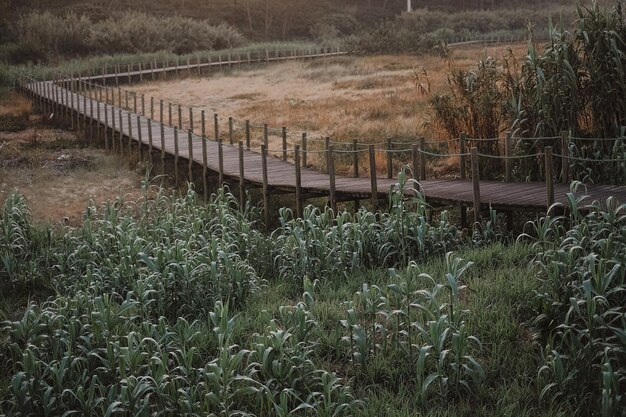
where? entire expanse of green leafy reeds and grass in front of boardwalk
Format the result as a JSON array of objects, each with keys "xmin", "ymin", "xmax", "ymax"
[{"xmin": 0, "ymin": 172, "xmax": 626, "ymax": 416}]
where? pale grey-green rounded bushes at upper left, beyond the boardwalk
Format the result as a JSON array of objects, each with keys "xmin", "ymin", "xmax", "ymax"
[{"xmin": 0, "ymin": 12, "xmax": 245, "ymax": 64}]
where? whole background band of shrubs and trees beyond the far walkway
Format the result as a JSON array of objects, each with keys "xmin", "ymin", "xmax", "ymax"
[{"xmin": 0, "ymin": 0, "xmax": 571, "ymax": 64}]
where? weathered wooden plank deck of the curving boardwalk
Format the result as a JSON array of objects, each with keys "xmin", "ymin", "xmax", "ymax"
[{"xmin": 23, "ymin": 78, "xmax": 626, "ymax": 221}]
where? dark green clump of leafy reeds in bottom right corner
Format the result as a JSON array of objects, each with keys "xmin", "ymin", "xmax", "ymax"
[{"xmin": 520, "ymin": 188, "xmax": 626, "ymax": 417}]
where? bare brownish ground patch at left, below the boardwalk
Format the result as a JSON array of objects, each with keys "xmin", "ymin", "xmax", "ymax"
[{"xmin": 0, "ymin": 126, "xmax": 141, "ymax": 225}]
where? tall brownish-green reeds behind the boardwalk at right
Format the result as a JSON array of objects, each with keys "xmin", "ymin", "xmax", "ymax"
[{"xmin": 431, "ymin": 1, "xmax": 626, "ymax": 139}]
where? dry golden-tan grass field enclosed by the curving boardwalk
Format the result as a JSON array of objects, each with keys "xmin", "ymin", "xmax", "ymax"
[{"xmin": 132, "ymin": 44, "xmax": 526, "ymax": 148}]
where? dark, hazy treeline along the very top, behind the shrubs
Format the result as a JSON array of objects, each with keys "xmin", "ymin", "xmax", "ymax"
[{"xmin": 0, "ymin": 0, "xmax": 573, "ymax": 41}]
